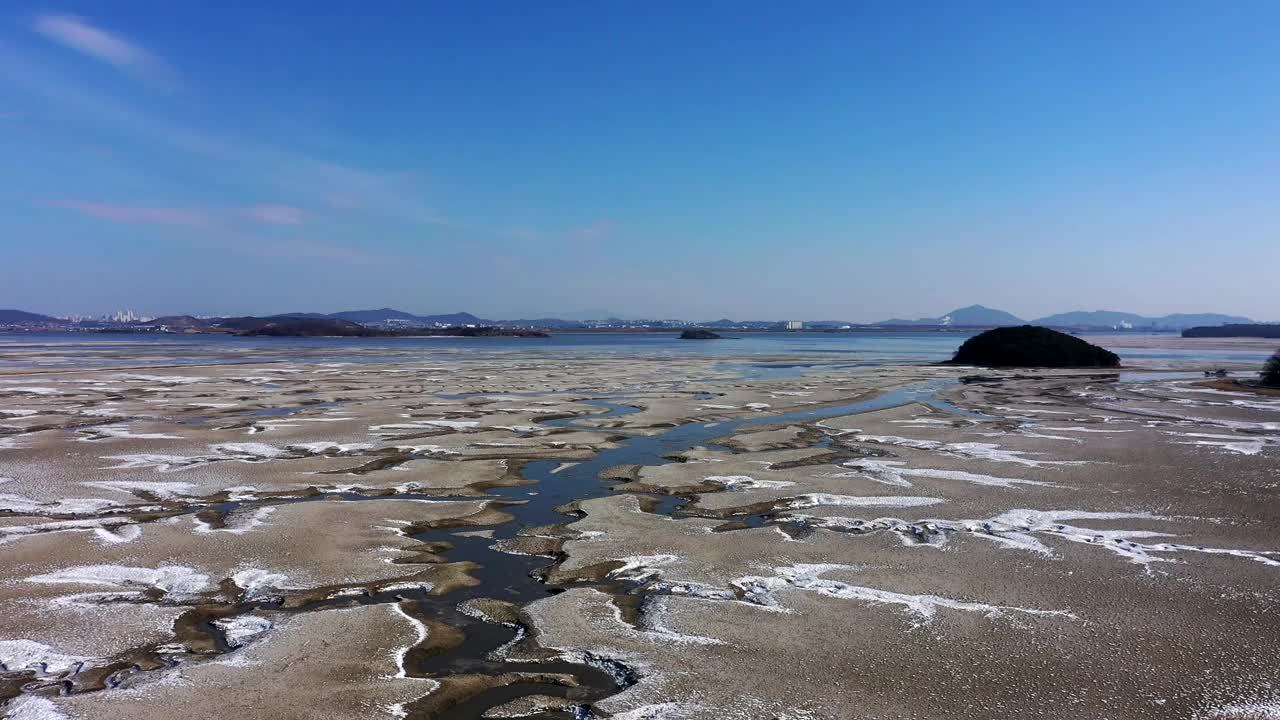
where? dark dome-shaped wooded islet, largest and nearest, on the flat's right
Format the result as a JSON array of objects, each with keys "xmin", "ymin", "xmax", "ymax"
[{"xmin": 950, "ymin": 325, "xmax": 1120, "ymax": 368}]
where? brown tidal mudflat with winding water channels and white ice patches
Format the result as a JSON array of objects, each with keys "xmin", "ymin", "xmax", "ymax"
[{"xmin": 0, "ymin": 341, "xmax": 1280, "ymax": 720}]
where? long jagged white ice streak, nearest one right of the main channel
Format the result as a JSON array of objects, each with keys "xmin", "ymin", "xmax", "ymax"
[{"xmin": 732, "ymin": 564, "xmax": 1075, "ymax": 623}]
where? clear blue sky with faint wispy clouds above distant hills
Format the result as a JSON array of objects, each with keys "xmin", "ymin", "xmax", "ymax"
[{"xmin": 0, "ymin": 0, "xmax": 1280, "ymax": 320}]
